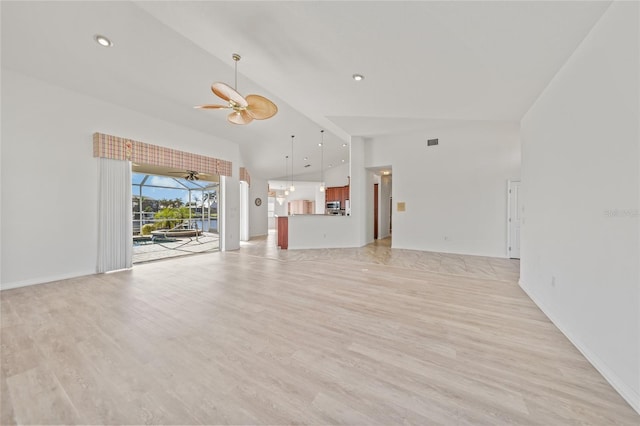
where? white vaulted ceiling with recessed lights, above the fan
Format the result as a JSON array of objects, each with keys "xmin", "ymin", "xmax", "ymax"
[{"xmin": 0, "ymin": 1, "xmax": 610, "ymax": 178}]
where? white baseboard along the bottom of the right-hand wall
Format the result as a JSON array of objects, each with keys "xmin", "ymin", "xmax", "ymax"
[{"xmin": 518, "ymin": 280, "xmax": 640, "ymax": 414}]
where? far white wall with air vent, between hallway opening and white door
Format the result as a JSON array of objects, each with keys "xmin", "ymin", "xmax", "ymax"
[{"xmin": 366, "ymin": 122, "xmax": 520, "ymax": 257}]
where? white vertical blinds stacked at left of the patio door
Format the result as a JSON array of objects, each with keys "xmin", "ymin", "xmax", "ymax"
[{"xmin": 98, "ymin": 158, "xmax": 133, "ymax": 273}]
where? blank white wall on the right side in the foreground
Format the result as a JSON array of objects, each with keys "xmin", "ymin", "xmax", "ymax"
[{"xmin": 524, "ymin": 2, "xmax": 640, "ymax": 411}]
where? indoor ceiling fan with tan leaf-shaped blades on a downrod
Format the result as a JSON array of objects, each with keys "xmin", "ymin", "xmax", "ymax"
[{"xmin": 195, "ymin": 53, "xmax": 278, "ymax": 124}]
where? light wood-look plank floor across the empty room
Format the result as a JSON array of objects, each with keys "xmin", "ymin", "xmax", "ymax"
[{"xmin": 0, "ymin": 235, "xmax": 640, "ymax": 425}]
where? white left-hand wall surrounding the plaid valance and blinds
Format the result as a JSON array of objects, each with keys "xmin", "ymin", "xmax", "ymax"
[{"xmin": 0, "ymin": 69, "xmax": 240, "ymax": 288}]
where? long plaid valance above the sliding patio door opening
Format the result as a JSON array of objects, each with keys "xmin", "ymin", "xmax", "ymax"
[{"xmin": 93, "ymin": 133, "xmax": 234, "ymax": 178}]
